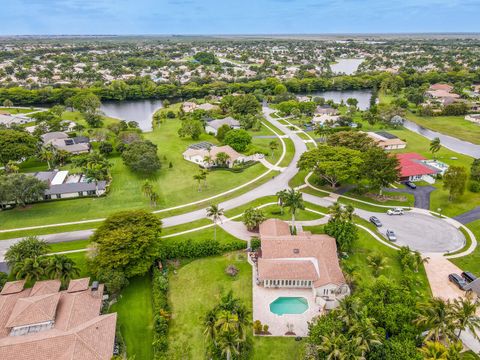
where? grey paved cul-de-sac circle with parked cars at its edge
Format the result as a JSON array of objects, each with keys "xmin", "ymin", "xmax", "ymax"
[{"xmin": 355, "ymin": 209, "xmax": 465, "ymax": 254}]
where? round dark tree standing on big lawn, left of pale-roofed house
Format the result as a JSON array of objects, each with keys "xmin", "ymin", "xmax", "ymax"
[{"xmin": 122, "ymin": 141, "xmax": 161, "ymax": 174}]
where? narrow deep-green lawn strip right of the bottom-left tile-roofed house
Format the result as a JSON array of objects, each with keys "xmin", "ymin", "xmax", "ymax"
[{"xmin": 110, "ymin": 274, "xmax": 153, "ymax": 360}]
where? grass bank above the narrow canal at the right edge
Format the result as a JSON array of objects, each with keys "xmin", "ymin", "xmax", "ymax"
[{"xmin": 406, "ymin": 112, "xmax": 480, "ymax": 144}]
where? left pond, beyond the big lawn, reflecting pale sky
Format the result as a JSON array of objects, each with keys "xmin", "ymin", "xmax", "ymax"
[{"xmin": 100, "ymin": 100, "xmax": 163, "ymax": 131}]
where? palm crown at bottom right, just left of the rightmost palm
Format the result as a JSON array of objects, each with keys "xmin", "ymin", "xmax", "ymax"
[{"xmin": 414, "ymin": 298, "xmax": 455, "ymax": 341}]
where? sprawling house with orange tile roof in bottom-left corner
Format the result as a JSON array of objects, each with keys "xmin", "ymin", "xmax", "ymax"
[{"xmin": 0, "ymin": 278, "xmax": 117, "ymax": 360}]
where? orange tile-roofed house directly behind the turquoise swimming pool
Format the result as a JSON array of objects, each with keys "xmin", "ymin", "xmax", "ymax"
[{"xmin": 255, "ymin": 219, "xmax": 350, "ymax": 309}]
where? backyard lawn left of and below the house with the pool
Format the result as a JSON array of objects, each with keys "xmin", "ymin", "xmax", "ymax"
[{"xmin": 169, "ymin": 253, "xmax": 301, "ymax": 360}]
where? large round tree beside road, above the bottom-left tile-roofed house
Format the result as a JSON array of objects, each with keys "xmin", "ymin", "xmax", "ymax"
[{"xmin": 90, "ymin": 210, "xmax": 162, "ymax": 279}]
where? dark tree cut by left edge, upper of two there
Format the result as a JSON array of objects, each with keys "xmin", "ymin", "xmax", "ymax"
[{"xmin": 0, "ymin": 129, "xmax": 38, "ymax": 166}]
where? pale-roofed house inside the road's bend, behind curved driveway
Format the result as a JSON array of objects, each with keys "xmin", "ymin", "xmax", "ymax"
[{"xmin": 183, "ymin": 141, "xmax": 254, "ymax": 168}]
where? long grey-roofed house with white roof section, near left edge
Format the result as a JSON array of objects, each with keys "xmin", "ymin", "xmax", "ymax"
[{"xmin": 29, "ymin": 170, "xmax": 108, "ymax": 200}]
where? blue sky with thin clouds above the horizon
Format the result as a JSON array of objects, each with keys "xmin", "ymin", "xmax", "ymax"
[{"xmin": 0, "ymin": 0, "xmax": 480, "ymax": 35}]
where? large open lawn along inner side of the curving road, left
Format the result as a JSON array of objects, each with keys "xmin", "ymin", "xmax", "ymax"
[{"xmin": 0, "ymin": 116, "xmax": 278, "ymax": 229}]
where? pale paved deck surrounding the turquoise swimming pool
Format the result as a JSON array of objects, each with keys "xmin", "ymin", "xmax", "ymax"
[{"xmin": 252, "ymin": 262, "xmax": 321, "ymax": 336}]
